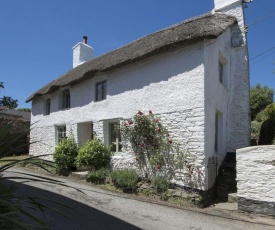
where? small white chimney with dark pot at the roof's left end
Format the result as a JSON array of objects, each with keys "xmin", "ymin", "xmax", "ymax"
[{"xmin": 73, "ymin": 36, "xmax": 94, "ymax": 68}]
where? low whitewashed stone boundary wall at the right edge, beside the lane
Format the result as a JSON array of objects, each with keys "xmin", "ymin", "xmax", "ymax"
[{"xmin": 237, "ymin": 145, "xmax": 275, "ymax": 215}]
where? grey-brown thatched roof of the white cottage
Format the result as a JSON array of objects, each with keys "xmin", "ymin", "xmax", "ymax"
[{"xmin": 26, "ymin": 13, "xmax": 237, "ymax": 102}]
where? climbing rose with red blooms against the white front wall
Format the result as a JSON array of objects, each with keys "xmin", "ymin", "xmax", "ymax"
[{"xmin": 120, "ymin": 110, "xmax": 201, "ymax": 179}]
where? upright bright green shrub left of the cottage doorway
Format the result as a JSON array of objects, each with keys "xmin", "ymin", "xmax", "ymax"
[{"xmin": 53, "ymin": 134, "xmax": 78, "ymax": 169}]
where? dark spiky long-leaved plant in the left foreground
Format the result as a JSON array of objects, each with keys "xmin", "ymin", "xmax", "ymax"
[{"xmin": 0, "ymin": 117, "xmax": 71, "ymax": 229}]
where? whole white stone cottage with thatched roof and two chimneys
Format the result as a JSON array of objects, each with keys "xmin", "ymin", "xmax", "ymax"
[{"xmin": 26, "ymin": 0, "xmax": 250, "ymax": 191}]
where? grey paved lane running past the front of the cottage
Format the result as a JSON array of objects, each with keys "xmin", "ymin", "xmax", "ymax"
[{"xmin": 2, "ymin": 169, "xmax": 275, "ymax": 230}]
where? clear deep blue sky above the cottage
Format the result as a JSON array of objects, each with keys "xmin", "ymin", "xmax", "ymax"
[{"xmin": 0, "ymin": 0, "xmax": 275, "ymax": 108}]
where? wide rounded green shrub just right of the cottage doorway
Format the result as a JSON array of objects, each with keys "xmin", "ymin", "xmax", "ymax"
[{"xmin": 76, "ymin": 138, "xmax": 111, "ymax": 169}]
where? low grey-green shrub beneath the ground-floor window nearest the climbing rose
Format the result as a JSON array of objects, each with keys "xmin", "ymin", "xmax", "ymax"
[{"xmin": 110, "ymin": 169, "xmax": 139, "ymax": 191}]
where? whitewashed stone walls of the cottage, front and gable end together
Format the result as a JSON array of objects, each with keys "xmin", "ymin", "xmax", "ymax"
[{"xmin": 27, "ymin": 1, "xmax": 249, "ymax": 190}]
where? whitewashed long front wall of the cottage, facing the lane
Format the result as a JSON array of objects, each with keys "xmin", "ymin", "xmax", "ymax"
[{"xmin": 30, "ymin": 43, "xmax": 207, "ymax": 189}]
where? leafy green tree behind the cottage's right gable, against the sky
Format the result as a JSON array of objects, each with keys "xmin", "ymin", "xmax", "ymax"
[{"xmin": 250, "ymin": 84, "xmax": 274, "ymax": 120}]
